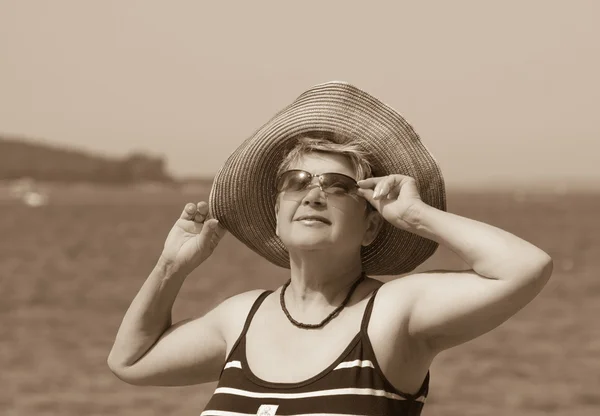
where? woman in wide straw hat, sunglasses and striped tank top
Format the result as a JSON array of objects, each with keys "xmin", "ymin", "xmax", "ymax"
[{"xmin": 108, "ymin": 82, "xmax": 552, "ymax": 416}]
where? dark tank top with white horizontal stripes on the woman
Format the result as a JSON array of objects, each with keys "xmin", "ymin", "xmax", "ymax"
[{"xmin": 201, "ymin": 291, "xmax": 429, "ymax": 416}]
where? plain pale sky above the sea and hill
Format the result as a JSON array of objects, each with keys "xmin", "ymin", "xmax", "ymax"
[{"xmin": 0, "ymin": 0, "xmax": 600, "ymax": 188}]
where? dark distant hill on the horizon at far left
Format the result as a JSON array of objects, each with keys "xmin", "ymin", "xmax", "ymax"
[{"xmin": 0, "ymin": 136, "xmax": 174, "ymax": 183}]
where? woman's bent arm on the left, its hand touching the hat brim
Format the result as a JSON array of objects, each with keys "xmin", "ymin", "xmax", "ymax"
[{"xmin": 108, "ymin": 202, "xmax": 231, "ymax": 385}]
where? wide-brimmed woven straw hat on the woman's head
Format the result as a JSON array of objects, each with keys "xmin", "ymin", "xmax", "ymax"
[{"xmin": 209, "ymin": 81, "xmax": 446, "ymax": 275}]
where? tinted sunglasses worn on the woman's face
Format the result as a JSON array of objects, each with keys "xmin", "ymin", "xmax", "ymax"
[{"xmin": 277, "ymin": 169, "xmax": 358, "ymax": 197}]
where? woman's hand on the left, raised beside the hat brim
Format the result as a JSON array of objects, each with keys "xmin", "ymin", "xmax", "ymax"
[{"xmin": 161, "ymin": 201, "xmax": 226, "ymax": 273}]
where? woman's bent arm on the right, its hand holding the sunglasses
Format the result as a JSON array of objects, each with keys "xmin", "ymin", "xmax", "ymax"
[{"xmin": 356, "ymin": 175, "xmax": 552, "ymax": 353}]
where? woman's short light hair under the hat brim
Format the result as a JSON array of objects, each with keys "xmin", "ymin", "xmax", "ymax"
[{"xmin": 277, "ymin": 131, "xmax": 372, "ymax": 180}]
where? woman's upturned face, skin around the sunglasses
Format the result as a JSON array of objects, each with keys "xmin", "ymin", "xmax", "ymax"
[{"xmin": 277, "ymin": 153, "xmax": 378, "ymax": 252}]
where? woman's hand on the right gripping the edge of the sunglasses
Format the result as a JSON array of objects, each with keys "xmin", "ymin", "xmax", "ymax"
[{"xmin": 358, "ymin": 174, "xmax": 426, "ymax": 231}]
